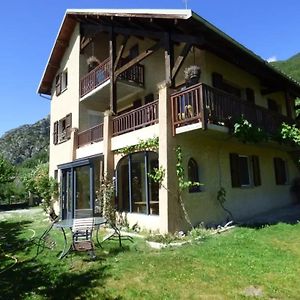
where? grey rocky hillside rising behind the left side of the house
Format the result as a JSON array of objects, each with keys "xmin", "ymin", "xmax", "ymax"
[{"xmin": 0, "ymin": 117, "xmax": 50, "ymax": 165}]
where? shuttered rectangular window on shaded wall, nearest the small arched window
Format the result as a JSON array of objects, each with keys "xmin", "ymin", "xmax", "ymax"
[{"xmin": 230, "ymin": 153, "xmax": 261, "ymax": 187}]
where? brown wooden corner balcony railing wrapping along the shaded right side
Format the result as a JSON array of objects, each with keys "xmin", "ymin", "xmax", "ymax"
[{"xmin": 171, "ymin": 83, "xmax": 293, "ymax": 135}]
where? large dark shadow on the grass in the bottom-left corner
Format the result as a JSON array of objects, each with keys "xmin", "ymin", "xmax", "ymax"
[{"xmin": 0, "ymin": 261, "xmax": 121, "ymax": 299}]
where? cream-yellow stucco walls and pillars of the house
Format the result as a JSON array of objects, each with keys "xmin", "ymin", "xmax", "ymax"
[{"xmin": 44, "ymin": 12, "xmax": 299, "ymax": 232}]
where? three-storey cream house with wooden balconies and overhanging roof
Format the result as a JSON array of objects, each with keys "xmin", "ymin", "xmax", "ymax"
[{"xmin": 38, "ymin": 9, "xmax": 300, "ymax": 232}]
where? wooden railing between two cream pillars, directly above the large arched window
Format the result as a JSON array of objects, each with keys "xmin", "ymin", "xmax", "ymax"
[{"xmin": 113, "ymin": 100, "xmax": 158, "ymax": 136}]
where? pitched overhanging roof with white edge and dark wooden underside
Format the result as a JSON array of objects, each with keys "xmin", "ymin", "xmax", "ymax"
[{"xmin": 37, "ymin": 9, "xmax": 300, "ymax": 95}]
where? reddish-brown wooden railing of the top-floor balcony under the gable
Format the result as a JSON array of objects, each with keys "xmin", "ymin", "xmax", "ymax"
[{"xmin": 80, "ymin": 58, "xmax": 144, "ymax": 97}]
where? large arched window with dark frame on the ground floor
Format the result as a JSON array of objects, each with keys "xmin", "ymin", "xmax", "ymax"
[{"xmin": 116, "ymin": 151, "xmax": 159, "ymax": 215}]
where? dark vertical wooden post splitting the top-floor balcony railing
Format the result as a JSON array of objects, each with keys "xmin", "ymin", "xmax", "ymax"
[{"xmin": 109, "ymin": 27, "xmax": 117, "ymax": 114}]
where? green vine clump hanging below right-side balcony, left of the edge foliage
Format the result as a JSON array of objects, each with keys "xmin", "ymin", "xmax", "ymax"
[{"xmin": 233, "ymin": 117, "xmax": 268, "ymax": 143}]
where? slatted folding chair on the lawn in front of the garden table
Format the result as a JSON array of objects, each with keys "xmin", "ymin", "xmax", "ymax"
[{"xmin": 72, "ymin": 218, "xmax": 96, "ymax": 258}]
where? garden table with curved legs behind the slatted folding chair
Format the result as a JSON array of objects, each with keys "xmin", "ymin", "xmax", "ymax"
[{"xmin": 53, "ymin": 217, "xmax": 107, "ymax": 259}]
